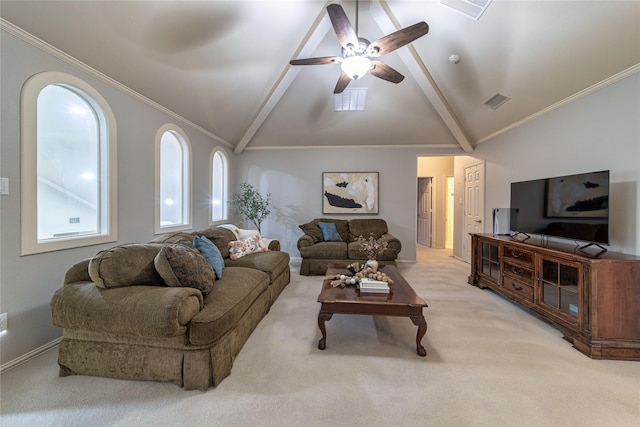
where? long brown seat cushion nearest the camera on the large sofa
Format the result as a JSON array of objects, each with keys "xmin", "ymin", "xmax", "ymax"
[{"xmin": 189, "ymin": 267, "xmax": 269, "ymax": 345}]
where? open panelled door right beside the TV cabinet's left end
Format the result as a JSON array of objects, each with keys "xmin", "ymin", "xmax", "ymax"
[{"xmin": 462, "ymin": 163, "xmax": 484, "ymax": 263}]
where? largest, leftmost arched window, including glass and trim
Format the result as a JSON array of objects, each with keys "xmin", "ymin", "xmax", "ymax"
[{"xmin": 21, "ymin": 72, "xmax": 117, "ymax": 255}]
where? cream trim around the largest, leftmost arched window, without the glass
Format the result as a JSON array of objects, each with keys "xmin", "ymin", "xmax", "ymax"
[{"xmin": 20, "ymin": 71, "xmax": 118, "ymax": 255}]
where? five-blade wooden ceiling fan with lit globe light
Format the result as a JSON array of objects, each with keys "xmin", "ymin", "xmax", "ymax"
[{"xmin": 289, "ymin": 2, "xmax": 429, "ymax": 93}]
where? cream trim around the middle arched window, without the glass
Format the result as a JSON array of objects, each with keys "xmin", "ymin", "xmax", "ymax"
[{"xmin": 154, "ymin": 123, "xmax": 192, "ymax": 234}]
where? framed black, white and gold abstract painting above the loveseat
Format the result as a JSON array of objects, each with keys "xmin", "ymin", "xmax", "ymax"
[{"xmin": 322, "ymin": 172, "xmax": 379, "ymax": 214}]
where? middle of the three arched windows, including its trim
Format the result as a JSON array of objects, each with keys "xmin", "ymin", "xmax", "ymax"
[{"xmin": 156, "ymin": 125, "xmax": 191, "ymax": 233}]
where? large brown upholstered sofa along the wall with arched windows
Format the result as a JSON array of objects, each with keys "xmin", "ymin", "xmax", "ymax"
[{"xmin": 51, "ymin": 227, "xmax": 290, "ymax": 390}]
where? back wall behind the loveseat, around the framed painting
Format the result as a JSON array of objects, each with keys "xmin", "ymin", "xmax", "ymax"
[{"xmin": 236, "ymin": 148, "xmax": 440, "ymax": 261}]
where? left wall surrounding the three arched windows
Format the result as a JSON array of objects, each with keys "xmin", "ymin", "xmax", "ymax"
[{"xmin": 0, "ymin": 31, "xmax": 230, "ymax": 364}]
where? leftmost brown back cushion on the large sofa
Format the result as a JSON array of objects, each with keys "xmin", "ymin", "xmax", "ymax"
[{"xmin": 89, "ymin": 243, "xmax": 164, "ymax": 289}]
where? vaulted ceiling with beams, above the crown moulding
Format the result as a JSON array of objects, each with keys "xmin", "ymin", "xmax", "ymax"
[{"xmin": 0, "ymin": 0, "xmax": 640, "ymax": 153}]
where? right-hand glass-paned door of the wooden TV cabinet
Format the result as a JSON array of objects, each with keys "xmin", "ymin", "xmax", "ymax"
[{"xmin": 542, "ymin": 258, "xmax": 581, "ymax": 318}]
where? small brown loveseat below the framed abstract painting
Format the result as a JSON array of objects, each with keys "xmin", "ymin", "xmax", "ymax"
[{"xmin": 297, "ymin": 218, "xmax": 402, "ymax": 276}]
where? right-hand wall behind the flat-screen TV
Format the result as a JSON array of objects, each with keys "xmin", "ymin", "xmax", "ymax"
[{"xmin": 456, "ymin": 74, "xmax": 640, "ymax": 256}]
